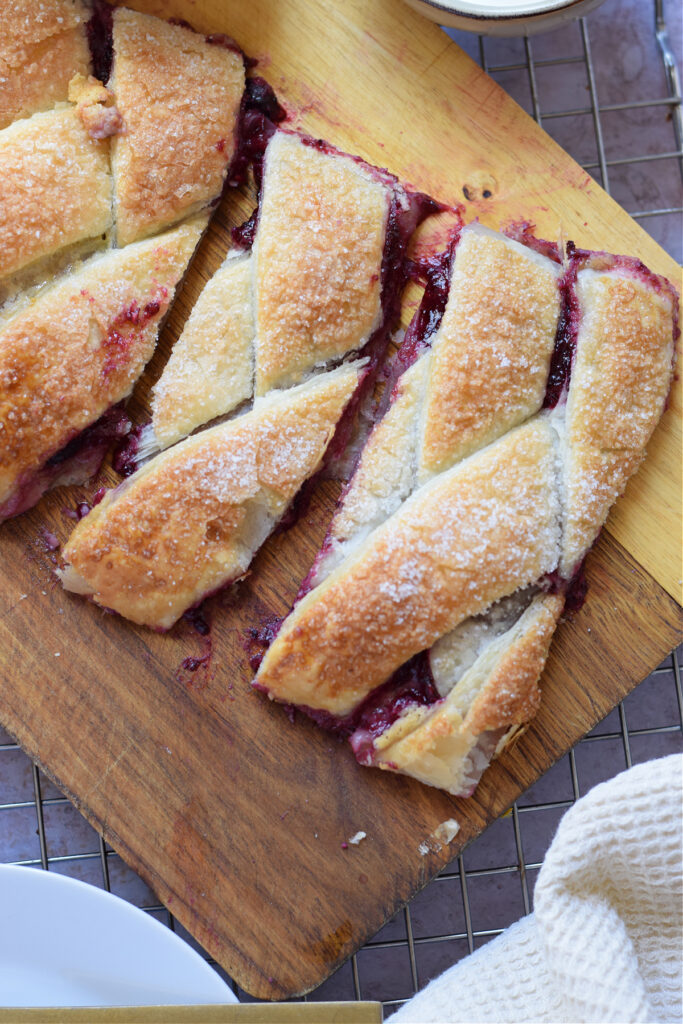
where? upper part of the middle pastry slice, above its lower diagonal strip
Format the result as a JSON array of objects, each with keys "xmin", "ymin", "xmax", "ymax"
[{"xmin": 142, "ymin": 126, "xmax": 437, "ymax": 451}]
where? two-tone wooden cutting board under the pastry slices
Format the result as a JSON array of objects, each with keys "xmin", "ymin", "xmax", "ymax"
[{"xmin": 0, "ymin": 0, "xmax": 681, "ymax": 998}]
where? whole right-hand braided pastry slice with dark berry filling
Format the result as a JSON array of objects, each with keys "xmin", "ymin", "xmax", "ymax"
[{"xmin": 255, "ymin": 226, "xmax": 678, "ymax": 795}]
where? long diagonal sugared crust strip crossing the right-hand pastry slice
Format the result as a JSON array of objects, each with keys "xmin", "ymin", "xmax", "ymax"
[{"xmin": 256, "ymin": 419, "xmax": 560, "ymax": 716}]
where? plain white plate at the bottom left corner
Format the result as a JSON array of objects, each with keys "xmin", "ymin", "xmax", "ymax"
[{"xmin": 0, "ymin": 865, "xmax": 238, "ymax": 1007}]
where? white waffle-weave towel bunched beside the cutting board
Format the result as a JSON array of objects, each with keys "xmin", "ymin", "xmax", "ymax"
[{"xmin": 391, "ymin": 755, "xmax": 683, "ymax": 1024}]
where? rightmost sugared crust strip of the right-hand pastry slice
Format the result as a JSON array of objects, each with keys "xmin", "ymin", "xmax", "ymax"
[{"xmin": 558, "ymin": 269, "xmax": 674, "ymax": 578}]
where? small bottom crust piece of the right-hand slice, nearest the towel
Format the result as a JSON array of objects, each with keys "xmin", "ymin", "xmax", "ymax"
[{"xmin": 366, "ymin": 594, "xmax": 564, "ymax": 796}]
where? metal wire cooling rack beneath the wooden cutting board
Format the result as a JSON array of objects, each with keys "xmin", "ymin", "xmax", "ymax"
[{"xmin": 0, "ymin": 0, "xmax": 683, "ymax": 1018}]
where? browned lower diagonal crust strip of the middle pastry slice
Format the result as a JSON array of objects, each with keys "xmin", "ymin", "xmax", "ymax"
[{"xmin": 63, "ymin": 362, "xmax": 362, "ymax": 629}]
